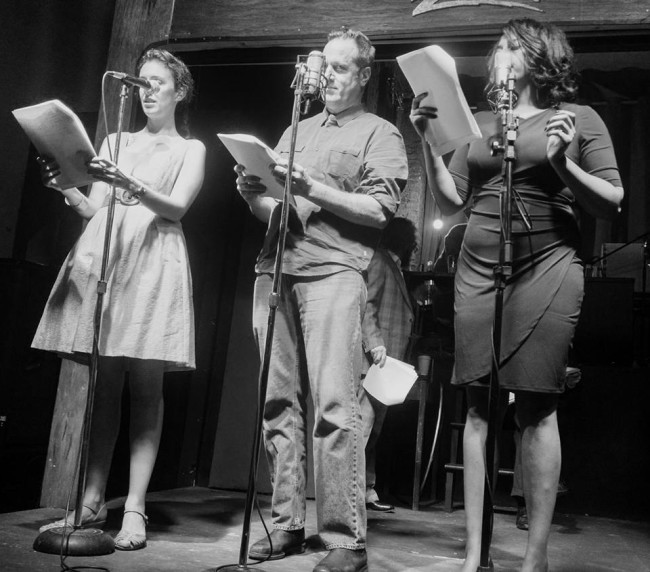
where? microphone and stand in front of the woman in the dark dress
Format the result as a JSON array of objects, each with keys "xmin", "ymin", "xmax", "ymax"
[{"xmin": 477, "ymin": 71, "xmax": 519, "ymax": 572}]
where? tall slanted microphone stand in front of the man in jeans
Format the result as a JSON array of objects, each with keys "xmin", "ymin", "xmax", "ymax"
[{"xmin": 215, "ymin": 56, "xmax": 316, "ymax": 572}]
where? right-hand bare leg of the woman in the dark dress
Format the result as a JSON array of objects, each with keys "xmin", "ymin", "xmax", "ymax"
[{"xmin": 516, "ymin": 392, "xmax": 562, "ymax": 572}]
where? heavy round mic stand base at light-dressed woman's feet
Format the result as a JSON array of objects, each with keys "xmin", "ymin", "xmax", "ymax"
[{"xmin": 33, "ymin": 526, "xmax": 115, "ymax": 556}]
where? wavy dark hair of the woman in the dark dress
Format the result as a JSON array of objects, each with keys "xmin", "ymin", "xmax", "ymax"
[{"xmin": 486, "ymin": 18, "xmax": 578, "ymax": 107}]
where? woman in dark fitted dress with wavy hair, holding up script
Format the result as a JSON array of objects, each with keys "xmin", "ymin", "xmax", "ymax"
[{"xmin": 411, "ymin": 19, "xmax": 623, "ymax": 572}]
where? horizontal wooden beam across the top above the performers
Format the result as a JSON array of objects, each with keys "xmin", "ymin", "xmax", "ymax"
[{"xmin": 170, "ymin": 0, "xmax": 650, "ymax": 47}]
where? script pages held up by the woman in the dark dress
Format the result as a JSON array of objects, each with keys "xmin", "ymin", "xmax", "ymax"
[{"xmin": 397, "ymin": 46, "xmax": 481, "ymax": 156}]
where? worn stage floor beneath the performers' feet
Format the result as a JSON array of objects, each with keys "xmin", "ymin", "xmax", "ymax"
[{"xmin": 0, "ymin": 488, "xmax": 650, "ymax": 572}]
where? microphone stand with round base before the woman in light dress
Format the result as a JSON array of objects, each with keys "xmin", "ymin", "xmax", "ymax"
[{"xmin": 34, "ymin": 84, "xmax": 129, "ymax": 556}]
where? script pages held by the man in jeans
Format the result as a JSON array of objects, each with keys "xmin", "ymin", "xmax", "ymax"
[{"xmin": 217, "ymin": 133, "xmax": 284, "ymax": 200}]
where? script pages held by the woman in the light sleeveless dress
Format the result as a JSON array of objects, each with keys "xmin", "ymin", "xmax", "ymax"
[{"xmin": 13, "ymin": 99, "xmax": 97, "ymax": 189}]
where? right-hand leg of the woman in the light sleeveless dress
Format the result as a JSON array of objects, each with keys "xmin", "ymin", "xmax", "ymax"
[{"xmin": 122, "ymin": 360, "xmax": 164, "ymax": 534}]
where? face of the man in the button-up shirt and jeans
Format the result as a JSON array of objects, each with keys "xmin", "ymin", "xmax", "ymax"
[{"xmin": 323, "ymin": 38, "xmax": 370, "ymax": 114}]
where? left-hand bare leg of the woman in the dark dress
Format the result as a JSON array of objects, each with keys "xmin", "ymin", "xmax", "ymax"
[{"xmin": 461, "ymin": 387, "xmax": 488, "ymax": 572}]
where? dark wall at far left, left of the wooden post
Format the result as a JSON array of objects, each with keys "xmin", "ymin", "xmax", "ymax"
[{"xmin": 0, "ymin": 0, "xmax": 115, "ymax": 511}]
